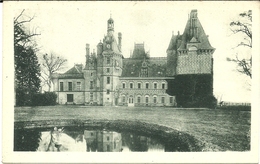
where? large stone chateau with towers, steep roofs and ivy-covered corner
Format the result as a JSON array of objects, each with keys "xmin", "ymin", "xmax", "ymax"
[{"xmin": 53, "ymin": 10, "xmax": 215, "ymax": 106}]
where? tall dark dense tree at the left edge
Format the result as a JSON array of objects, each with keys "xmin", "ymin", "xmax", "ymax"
[{"xmin": 14, "ymin": 10, "xmax": 41, "ymax": 106}]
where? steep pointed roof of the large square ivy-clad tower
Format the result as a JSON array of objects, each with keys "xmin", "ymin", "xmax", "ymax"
[{"xmin": 178, "ymin": 10, "xmax": 214, "ymax": 50}]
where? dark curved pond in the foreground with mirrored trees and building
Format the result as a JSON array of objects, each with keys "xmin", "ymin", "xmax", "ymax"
[{"xmin": 14, "ymin": 127, "xmax": 193, "ymax": 152}]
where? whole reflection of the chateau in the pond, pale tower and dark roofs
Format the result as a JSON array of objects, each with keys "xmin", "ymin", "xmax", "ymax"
[{"xmin": 84, "ymin": 130, "xmax": 164, "ymax": 152}]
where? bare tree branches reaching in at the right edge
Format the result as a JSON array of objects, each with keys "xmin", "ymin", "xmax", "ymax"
[{"xmin": 227, "ymin": 10, "xmax": 252, "ymax": 78}]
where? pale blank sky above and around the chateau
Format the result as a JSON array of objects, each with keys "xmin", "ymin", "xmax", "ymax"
[{"xmin": 10, "ymin": 1, "xmax": 254, "ymax": 102}]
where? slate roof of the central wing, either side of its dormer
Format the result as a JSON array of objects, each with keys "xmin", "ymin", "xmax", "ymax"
[{"xmin": 121, "ymin": 57, "xmax": 167, "ymax": 77}]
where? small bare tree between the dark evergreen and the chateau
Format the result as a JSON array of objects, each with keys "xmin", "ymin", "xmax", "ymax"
[{"xmin": 41, "ymin": 53, "xmax": 67, "ymax": 91}]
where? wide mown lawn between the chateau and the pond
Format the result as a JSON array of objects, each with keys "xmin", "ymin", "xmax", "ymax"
[{"xmin": 14, "ymin": 106, "xmax": 251, "ymax": 151}]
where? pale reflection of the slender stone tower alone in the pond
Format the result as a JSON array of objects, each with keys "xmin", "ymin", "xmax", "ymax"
[{"xmin": 84, "ymin": 130, "xmax": 122, "ymax": 152}]
